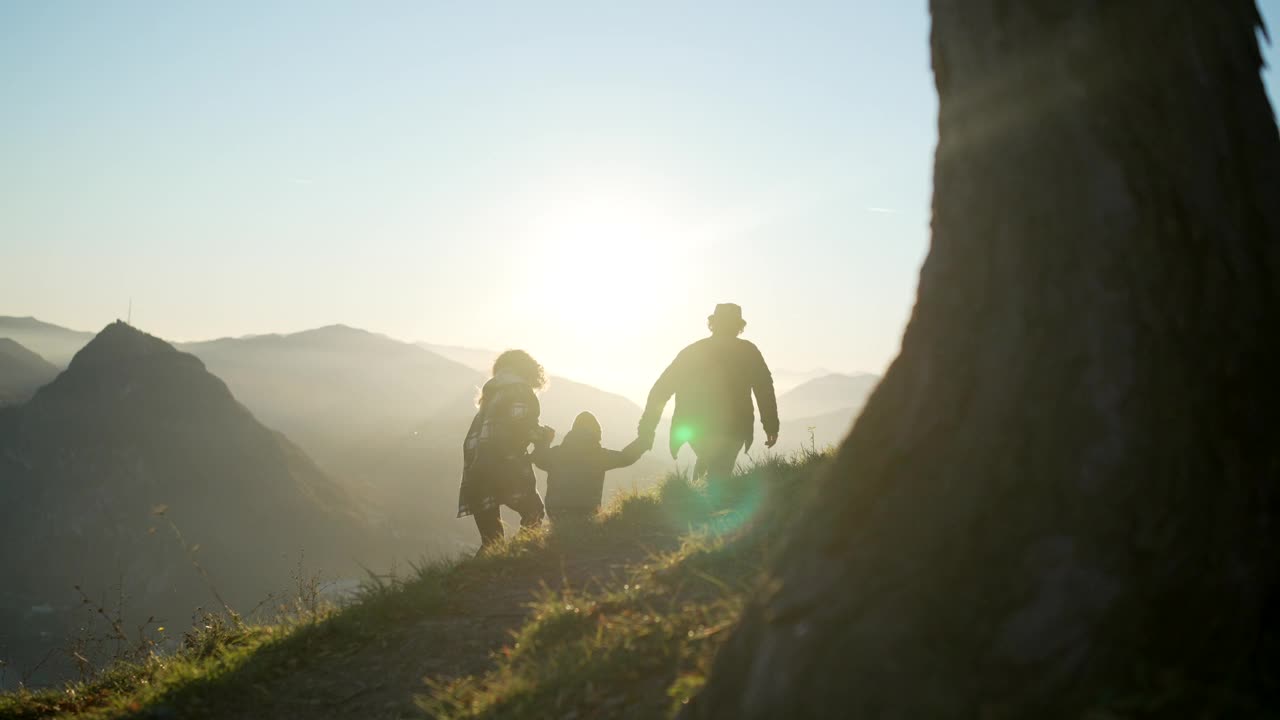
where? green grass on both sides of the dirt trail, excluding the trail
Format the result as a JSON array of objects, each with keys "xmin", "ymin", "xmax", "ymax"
[{"xmin": 0, "ymin": 452, "xmax": 827, "ymax": 719}]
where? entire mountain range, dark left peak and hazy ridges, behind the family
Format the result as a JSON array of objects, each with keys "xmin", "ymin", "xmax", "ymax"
[{"xmin": 0, "ymin": 318, "xmax": 878, "ymax": 681}]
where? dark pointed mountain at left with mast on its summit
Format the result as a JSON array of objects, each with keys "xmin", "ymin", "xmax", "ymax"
[{"xmin": 0, "ymin": 323, "xmax": 373, "ymax": 681}]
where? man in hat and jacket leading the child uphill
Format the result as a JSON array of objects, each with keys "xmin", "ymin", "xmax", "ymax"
[{"xmin": 640, "ymin": 302, "xmax": 778, "ymax": 479}]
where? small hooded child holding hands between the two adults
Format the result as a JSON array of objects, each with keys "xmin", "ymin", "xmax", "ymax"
[{"xmin": 534, "ymin": 413, "xmax": 648, "ymax": 523}]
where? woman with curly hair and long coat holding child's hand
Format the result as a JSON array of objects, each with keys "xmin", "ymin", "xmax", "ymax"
[{"xmin": 458, "ymin": 350, "xmax": 556, "ymax": 548}]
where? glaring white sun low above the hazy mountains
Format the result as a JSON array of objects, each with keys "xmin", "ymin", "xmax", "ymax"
[{"xmin": 511, "ymin": 182, "xmax": 723, "ymax": 397}]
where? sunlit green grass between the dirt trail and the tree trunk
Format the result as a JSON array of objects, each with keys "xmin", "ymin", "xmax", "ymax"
[{"xmin": 419, "ymin": 454, "xmax": 826, "ymax": 719}]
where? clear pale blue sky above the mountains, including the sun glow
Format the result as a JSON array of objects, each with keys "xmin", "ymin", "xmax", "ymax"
[{"xmin": 0, "ymin": 0, "xmax": 1280, "ymax": 396}]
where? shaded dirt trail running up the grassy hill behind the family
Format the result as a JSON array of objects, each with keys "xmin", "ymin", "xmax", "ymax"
[{"xmin": 222, "ymin": 534, "xmax": 678, "ymax": 719}]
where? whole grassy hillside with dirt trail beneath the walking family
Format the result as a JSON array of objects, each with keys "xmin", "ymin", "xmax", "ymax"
[{"xmin": 0, "ymin": 445, "xmax": 827, "ymax": 719}]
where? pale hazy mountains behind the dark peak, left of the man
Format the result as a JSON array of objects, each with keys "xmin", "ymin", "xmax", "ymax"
[{"xmin": 0, "ymin": 318, "xmax": 669, "ymax": 552}]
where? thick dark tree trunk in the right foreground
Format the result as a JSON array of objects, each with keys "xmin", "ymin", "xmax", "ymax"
[{"xmin": 685, "ymin": 0, "xmax": 1280, "ymax": 719}]
